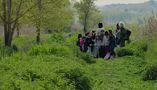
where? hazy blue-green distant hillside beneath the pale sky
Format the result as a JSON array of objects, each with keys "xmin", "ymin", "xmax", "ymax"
[{"xmin": 100, "ymin": 0, "xmax": 157, "ymax": 24}]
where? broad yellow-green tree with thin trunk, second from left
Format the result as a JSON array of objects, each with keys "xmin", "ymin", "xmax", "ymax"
[{"xmin": 27, "ymin": 0, "xmax": 73, "ymax": 40}]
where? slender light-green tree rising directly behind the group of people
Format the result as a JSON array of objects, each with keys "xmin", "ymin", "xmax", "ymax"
[{"xmin": 75, "ymin": 0, "xmax": 98, "ymax": 33}]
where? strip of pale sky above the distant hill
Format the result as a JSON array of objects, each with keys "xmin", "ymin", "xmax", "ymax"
[{"xmin": 96, "ymin": 0, "xmax": 149, "ymax": 6}]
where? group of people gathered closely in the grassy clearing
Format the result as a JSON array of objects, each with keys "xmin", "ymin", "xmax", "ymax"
[{"xmin": 77, "ymin": 22, "xmax": 131, "ymax": 59}]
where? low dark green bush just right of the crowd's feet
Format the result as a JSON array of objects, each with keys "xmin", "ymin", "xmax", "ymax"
[{"xmin": 116, "ymin": 48, "xmax": 134, "ymax": 57}]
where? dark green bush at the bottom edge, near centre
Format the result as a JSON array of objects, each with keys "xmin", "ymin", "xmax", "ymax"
[{"xmin": 65, "ymin": 68, "xmax": 91, "ymax": 90}]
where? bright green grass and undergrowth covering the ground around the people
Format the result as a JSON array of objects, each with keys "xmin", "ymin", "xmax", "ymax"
[{"xmin": 0, "ymin": 34, "xmax": 157, "ymax": 90}]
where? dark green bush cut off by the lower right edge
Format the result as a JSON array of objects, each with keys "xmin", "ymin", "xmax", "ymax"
[{"xmin": 143, "ymin": 65, "xmax": 157, "ymax": 81}]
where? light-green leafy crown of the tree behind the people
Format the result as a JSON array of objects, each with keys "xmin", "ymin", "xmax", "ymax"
[{"xmin": 75, "ymin": 0, "xmax": 102, "ymax": 32}]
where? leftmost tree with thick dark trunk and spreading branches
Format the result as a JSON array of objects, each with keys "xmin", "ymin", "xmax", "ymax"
[{"xmin": 0, "ymin": 0, "xmax": 35, "ymax": 47}]
